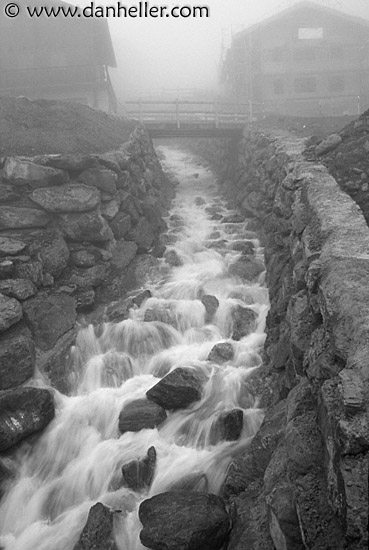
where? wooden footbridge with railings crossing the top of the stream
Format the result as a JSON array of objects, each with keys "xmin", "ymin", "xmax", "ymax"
[{"xmin": 125, "ymin": 99, "xmax": 252, "ymax": 139}]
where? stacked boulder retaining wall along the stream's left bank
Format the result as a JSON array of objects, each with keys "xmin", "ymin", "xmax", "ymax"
[{"xmin": 0, "ymin": 126, "xmax": 173, "ymax": 458}]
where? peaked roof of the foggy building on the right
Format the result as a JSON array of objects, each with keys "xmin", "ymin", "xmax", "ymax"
[{"xmin": 235, "ymin": 0, "xmax": 369, "ymax": 39}]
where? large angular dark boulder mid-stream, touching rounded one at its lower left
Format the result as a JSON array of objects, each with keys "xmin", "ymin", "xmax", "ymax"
[{"xmin": 146, "ymin": 367, "xmax": 203, "ymax": 410}]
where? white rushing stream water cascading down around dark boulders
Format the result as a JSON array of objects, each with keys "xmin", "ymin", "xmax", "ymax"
[{"xmin": 0, "ymin": 148, "xmax": 268, "ymax": 550}]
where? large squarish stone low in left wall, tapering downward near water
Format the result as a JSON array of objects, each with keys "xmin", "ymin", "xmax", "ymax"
[{"xmin": 23, "ymin": 292, "xmax": 76, "ymax": 350}]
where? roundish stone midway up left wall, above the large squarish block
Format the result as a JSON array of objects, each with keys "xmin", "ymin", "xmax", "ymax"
[{"xmin": 30, "ymin": 230, "xmax": 70, "ymax": 277}]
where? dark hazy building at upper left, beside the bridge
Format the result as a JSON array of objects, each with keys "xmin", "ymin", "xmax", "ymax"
[{"xmin": 0, "ymin": 0, "xmax": 116, "ymax": 112}]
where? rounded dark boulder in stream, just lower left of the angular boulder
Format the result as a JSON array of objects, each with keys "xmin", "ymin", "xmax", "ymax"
[{"xmin": 119, "ymin": 399, "xmax": 167, "ymax": 434}]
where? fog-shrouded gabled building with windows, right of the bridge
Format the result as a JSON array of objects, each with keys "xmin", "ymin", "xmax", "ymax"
[{"xmin": 222, "ymin": 1, "xmax": 369, "ymax": 116}]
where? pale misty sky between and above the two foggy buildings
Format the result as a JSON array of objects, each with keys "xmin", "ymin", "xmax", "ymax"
[{"xmin": 76, "ymin": 0, "xmax": 369, "ymax": 99}]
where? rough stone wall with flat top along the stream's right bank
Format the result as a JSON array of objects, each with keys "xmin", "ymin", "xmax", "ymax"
[{"xmin": 191, "ymin": 132, "xmax": 369, "ymax": 550}]
